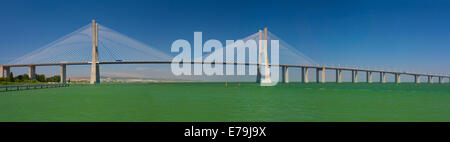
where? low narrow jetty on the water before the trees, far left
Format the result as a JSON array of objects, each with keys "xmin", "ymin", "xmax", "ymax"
[{"xmin": 0, "ymin": 83, "xmax": 70, "ymax": 92}]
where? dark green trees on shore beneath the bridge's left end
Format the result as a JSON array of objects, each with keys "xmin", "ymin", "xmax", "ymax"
[{"xmin": 0, "ymin": 72, "xmax": 61, "ymax": 84}]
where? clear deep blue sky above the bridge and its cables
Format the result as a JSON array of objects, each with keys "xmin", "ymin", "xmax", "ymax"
[{"xmin": 0, "ymin": 0, "xmax": 450, "ymax": 75}]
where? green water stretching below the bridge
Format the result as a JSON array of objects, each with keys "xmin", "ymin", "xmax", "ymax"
[{"xmin": 0, "ymin": 83, "xmax": 450, "ymax": 122}]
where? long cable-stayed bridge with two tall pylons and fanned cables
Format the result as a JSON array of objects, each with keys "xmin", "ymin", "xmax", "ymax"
[{"xmin": 0, "ymin": 21, "xmax": 450, "ymax": 84}]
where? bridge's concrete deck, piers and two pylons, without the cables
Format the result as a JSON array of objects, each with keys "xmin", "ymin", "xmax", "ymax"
[{"xmin": 0, "ymin": 20, "xmax": 450, "ymax": 84}]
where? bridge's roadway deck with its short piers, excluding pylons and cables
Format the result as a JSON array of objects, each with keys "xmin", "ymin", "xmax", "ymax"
[{"xmin": 0, "ymin": 61, "xmax": 450, "ymax": 83}]
